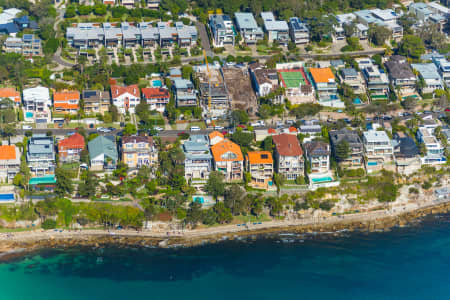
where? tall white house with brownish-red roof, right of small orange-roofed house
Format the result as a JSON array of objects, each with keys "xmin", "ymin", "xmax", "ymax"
[{"xmin": 272, "ymin": 133, "xmax": 305, "ymax": 180}]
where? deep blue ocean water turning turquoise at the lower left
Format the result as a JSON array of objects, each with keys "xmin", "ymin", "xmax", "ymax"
[{"xmin": 0, "ymin": 216, "xmax": 450, "ymax": 300}]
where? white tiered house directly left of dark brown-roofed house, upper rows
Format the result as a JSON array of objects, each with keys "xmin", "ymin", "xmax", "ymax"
[{"xmin": 356, "ymin": 58, "xmax": 389, "ymax": 100}]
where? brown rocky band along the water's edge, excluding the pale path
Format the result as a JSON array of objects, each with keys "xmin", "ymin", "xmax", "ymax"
[{"xmin": 0, "ymin": 202, "xmax": 450, "ymax": 261}]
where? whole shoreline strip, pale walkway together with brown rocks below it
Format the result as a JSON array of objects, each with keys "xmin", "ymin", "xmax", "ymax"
[{"xmin": 0, "ymin": 199, "xmax": 450, "ymax": 261}]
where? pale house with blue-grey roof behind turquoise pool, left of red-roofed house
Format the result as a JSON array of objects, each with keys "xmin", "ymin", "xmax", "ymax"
[{"xmin": 26, "ymin": 134, "xmax": 56, "ymax": 178}]
